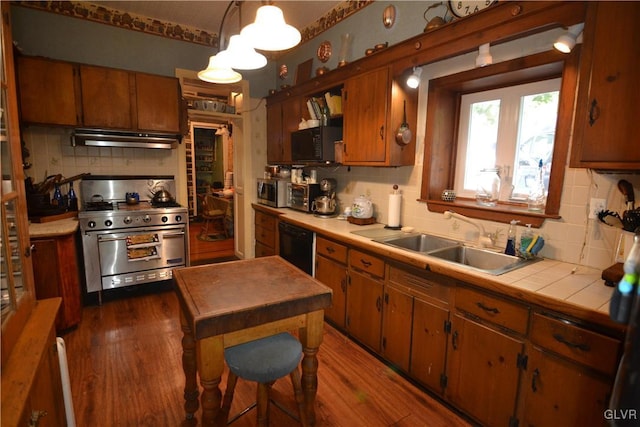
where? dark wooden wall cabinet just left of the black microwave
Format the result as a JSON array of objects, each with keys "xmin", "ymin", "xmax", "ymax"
[{"xmin": 267, "ymin": 93, "xmax": 302, "ymax": 164}]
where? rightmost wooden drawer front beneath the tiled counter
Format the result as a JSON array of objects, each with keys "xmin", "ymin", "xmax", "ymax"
[{"xmin": 531, "ymin": 313, "xmax": 621, "ymax": 375}]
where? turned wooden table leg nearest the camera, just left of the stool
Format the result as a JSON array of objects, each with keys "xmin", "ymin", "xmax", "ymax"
[{"xmin": 196, "ymin": 335, "xmax": 227, "ymax": 426}]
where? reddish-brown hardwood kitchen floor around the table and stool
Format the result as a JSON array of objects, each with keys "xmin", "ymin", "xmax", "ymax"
[{"xmin": 64, "ymin": 288, "xmax": 470, "ymax": 427}]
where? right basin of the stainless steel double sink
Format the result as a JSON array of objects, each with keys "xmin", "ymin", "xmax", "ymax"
[{"xmin": 428, "ymin": 246, "xmax": 539, "ymax": 275}]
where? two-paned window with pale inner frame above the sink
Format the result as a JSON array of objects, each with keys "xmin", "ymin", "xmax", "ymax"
[{"xmin": 455, "ymin": 79, "xmax": 561, "ymax": 202}]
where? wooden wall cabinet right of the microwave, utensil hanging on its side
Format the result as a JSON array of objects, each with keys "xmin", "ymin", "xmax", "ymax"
[{"xmin": 343, "ymin": 67, "xmax": 418, "ymax": 166}]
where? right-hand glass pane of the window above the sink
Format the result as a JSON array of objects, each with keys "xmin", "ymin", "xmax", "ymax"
[{"xmin": 512, "ymin": 91, "xmax": 559, "ymax": 200}]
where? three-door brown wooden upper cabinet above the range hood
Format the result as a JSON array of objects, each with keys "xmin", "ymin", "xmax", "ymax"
[{"xmin": 18, "ymin": 57, "xmax": 180, "ymax": 133}]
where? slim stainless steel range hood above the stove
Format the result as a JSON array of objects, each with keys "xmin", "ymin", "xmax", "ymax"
[{"xmin": 71, "ymin": 129, "xmax": 180, "ymax": 150}]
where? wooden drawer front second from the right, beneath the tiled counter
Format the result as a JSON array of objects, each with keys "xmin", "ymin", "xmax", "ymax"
[{"xmin": 456, "ymin": 288, "xmax": 529, "ymax": 335}]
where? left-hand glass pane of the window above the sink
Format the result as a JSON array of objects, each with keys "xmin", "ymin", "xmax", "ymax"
[{"xmin": 464, "ymin": 99, "xmax": 500, "ymax": 191}]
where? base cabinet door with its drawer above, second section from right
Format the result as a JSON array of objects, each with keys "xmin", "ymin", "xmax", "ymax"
[{"xmin": 445, "ymin": 287, "xmax": 529, "ymax": 426}]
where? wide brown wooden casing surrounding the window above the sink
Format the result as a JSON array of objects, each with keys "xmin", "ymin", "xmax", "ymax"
[{"xmin": 419, "ymin": 46, "xmax": 580, "ymax": 227}]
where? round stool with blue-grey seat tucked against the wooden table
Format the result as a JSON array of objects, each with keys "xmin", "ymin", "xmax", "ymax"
[{"xmin": 222, "ymin": 332, "xmax": 307, "ymax": 426}]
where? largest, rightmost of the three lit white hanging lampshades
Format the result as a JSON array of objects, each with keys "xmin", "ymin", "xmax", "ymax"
[{"xmin": 240, "ymin": 5, "xmax": 302, "ymax": 51}]
